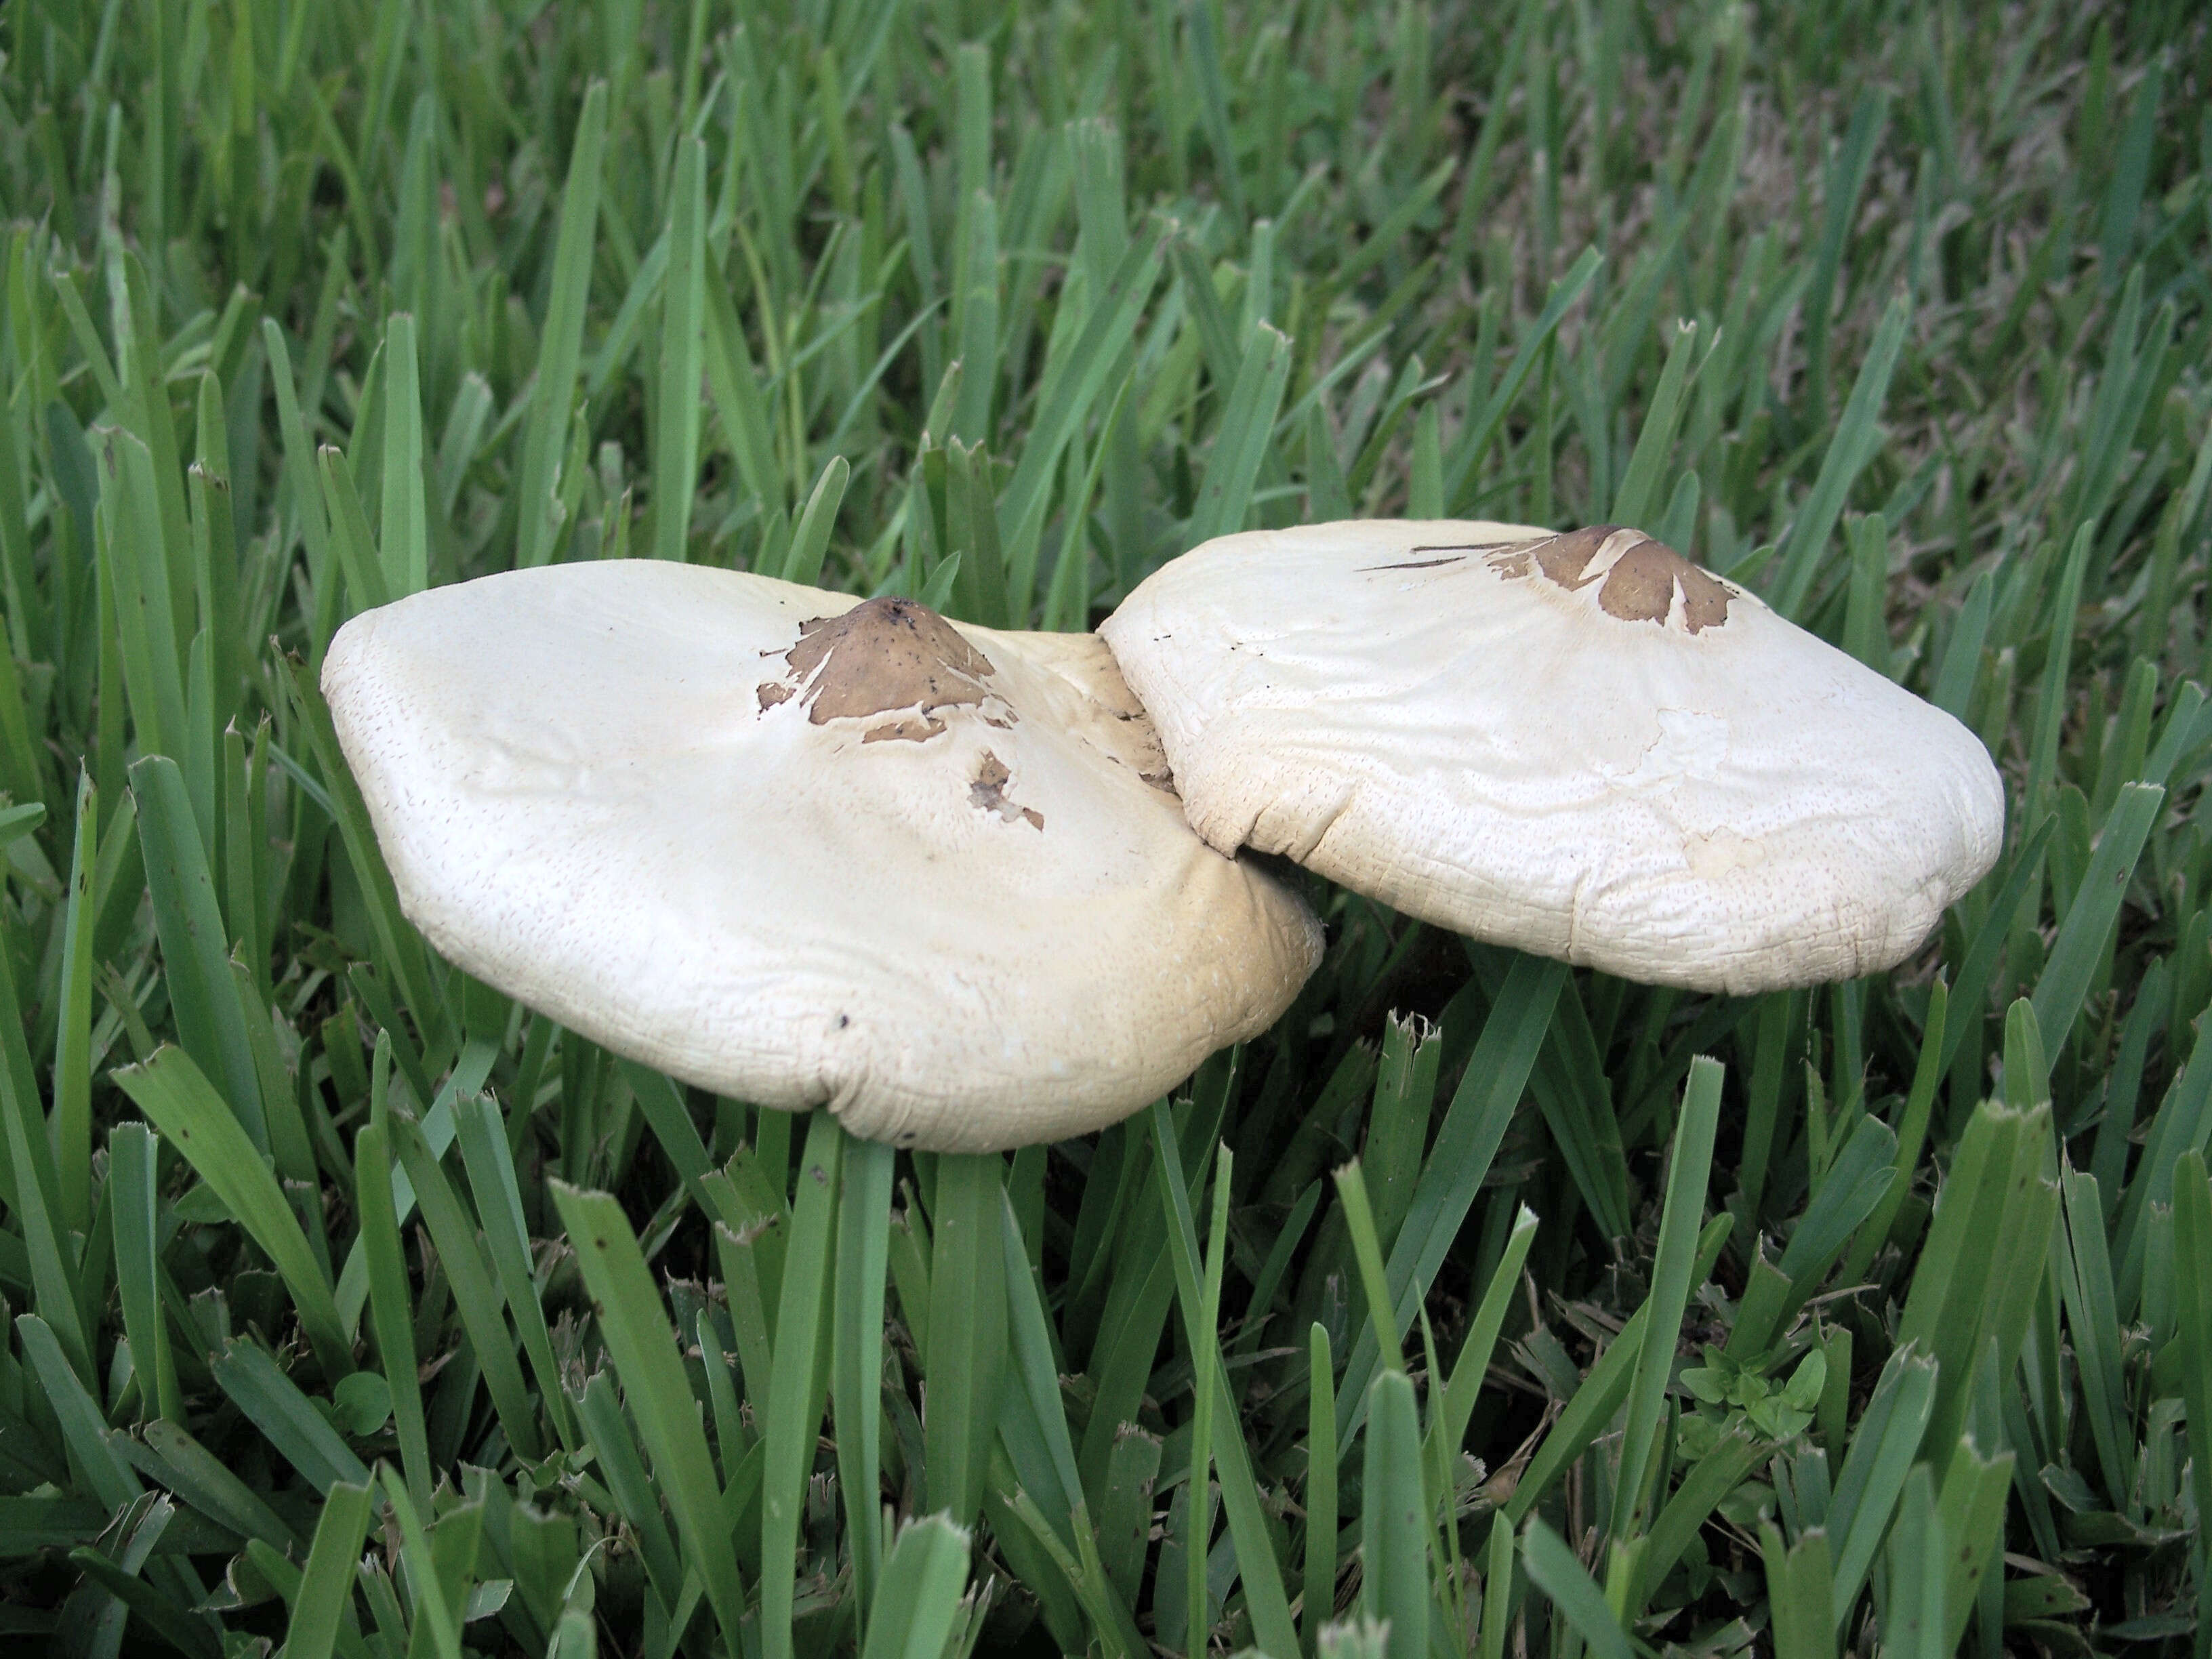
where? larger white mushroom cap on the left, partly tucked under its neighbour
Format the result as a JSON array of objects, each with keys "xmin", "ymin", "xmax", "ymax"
[{"xmin": 323, "ymin": 560, "xmax": 1321, "ymax": 1150}]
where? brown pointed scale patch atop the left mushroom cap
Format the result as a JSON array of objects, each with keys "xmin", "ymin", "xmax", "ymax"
[{"xmin": 754, "ymin": 600, "xmax": 1013, "ymax": 743}]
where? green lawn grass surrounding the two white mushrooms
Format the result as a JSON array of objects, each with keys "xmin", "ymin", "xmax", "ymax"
[{"xmin": 0, "ymin": 0, "xmax": 2212, "ymax": 1659}]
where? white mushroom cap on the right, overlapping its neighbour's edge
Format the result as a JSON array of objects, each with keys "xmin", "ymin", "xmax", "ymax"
[{"xmin": 1101, "ymin": 520, "xmax": 2004, "ymax": 994}]
